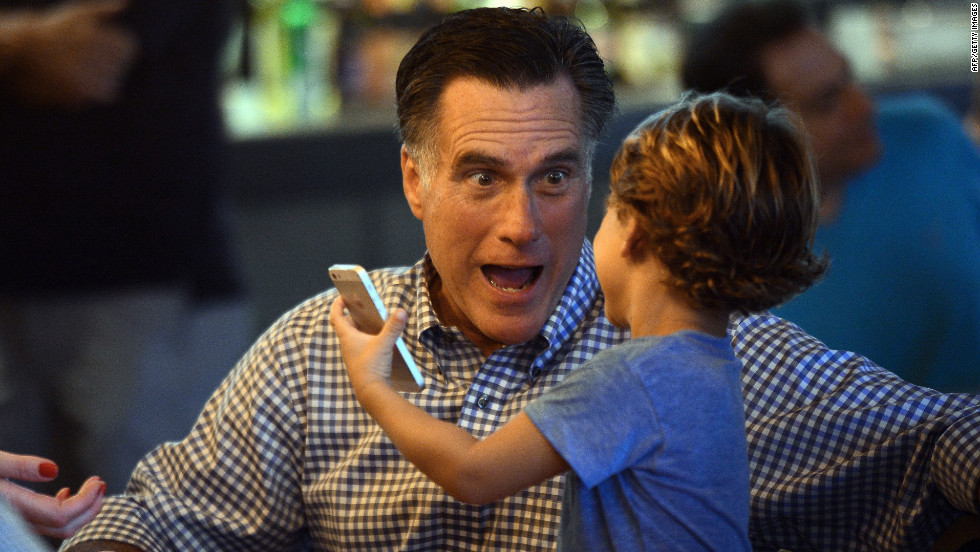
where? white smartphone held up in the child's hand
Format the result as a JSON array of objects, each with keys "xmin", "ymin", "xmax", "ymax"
[{"xmin": 329, "ymin": 264, "xmax": 425, "ymax": 392}]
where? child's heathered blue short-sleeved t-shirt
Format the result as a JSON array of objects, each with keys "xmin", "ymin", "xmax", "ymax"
[{"xmin": 525, "ymin": 332, "xmax": 751, "ymax": 552}]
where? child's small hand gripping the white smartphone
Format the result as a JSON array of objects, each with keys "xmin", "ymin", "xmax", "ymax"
[{"xmin": 330, "ymin": 297, "xmax": 408, "ymax": 398}]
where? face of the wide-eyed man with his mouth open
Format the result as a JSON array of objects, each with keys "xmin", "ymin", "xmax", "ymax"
[{"xmin": 402, "ymin": 78, "xmax": 591, "ymax": 354}]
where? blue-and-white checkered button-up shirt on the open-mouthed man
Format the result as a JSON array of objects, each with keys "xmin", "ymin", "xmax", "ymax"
[{"xmin": 69, "ymin": 243, "xmax": 980, "ymax": 552}]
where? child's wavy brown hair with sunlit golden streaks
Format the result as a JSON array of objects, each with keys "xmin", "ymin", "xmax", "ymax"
[{"xmin": 609, "ymin": 93, "xmax": 827, "ymax": 312}]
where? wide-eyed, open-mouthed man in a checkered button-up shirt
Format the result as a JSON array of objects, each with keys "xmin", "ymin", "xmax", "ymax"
[{"xmin": 66, "ymin": 8, "xmax": 980, "ymax": 551}]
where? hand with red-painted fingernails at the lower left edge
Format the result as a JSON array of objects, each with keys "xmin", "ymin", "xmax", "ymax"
[{"xmin": 0, "ymin": 451, "xmax": 105, "ymax": 539}]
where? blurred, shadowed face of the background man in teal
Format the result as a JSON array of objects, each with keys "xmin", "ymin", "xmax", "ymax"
[{"xmin": 762, "ymin": 29, "xmax": 880, "ymax": 185}]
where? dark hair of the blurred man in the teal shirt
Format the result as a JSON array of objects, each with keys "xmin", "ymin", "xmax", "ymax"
[{"xmin": 681, "ymin": 0, "xmax": 811, "ymax": 101}]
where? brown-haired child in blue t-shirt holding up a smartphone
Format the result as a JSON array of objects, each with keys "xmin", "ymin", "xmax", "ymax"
[{"xmin": 330, "ymin": 94, "xmax": 826, "ymax": 551}]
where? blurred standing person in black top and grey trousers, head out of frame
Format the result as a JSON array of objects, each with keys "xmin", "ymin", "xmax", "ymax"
[{"xmin": 0, "ymin": 0, "xmax": 250, "ymax": 491}]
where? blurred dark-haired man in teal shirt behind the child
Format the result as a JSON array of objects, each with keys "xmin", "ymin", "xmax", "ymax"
[{"xmin": 683, "ymin": 0, "xmax": 980, "ymax": 393}]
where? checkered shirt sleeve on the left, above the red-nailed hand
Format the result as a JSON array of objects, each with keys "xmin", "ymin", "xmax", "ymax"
[{"xmin": 65, "ymin": 300, "xmax": 316, "ymax": 552}]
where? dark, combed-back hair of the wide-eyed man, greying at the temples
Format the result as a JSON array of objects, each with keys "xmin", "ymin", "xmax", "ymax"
[{"xmin": 395, "ymin": 8, "xmax": 615, "ymax": 162}]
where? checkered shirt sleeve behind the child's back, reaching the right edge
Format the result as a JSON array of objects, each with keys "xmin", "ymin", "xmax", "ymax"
[{"xmin": 729, "ymin": 315, "xmax": 980, "ymax": 550}]
